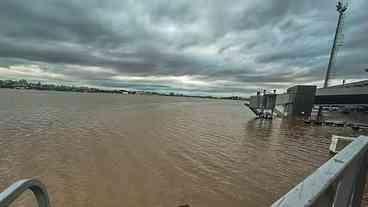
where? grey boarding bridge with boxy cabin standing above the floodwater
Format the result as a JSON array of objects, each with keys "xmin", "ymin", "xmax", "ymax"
[{"xmin": 246, "ymin": 80, "xmax": 368, "ymax": 117}]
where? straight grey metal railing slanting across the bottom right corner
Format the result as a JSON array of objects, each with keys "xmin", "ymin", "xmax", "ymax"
[{"xmin": 271, "ymin": 136, "xmax": 368, "ymax": 207}]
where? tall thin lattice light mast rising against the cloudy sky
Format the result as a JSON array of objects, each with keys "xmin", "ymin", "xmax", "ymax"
[{"xmin": 323, "ymin": 1, "xmax": 347, "ymax": 88}]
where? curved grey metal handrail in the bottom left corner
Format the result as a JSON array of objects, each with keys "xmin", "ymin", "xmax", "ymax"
[{"xmin": 0, "ymin": 179, "xmax": 50, "ymax": 207}]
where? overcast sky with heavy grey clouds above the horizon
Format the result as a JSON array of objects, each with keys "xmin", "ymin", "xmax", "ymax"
[{"xmin": 0, "ymin": 0, "xmax": 368, "ymax": 96}]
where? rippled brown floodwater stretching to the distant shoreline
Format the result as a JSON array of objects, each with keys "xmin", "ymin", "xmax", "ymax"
[{"xmin": 0, "ymin": 90, "xmax": 365, "ymax": 207}]
